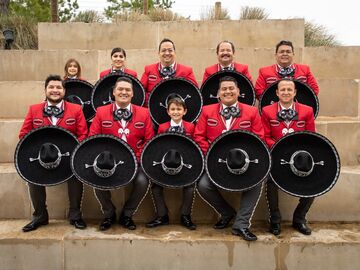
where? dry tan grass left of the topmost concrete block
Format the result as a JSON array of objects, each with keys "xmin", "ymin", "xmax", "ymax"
[{"xmin": 0, "ymin": 15, "xmax": 38, "ymax": 50}]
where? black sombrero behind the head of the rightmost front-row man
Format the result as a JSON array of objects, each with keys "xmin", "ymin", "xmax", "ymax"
[{"xmin": 259, "ymin": 80, "xmax": 319, "ymax": 118}]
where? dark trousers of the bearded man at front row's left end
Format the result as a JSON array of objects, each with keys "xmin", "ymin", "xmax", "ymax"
[{"xmin": 28, "ymin": 177, "xmax": 84, "ymax": 220}]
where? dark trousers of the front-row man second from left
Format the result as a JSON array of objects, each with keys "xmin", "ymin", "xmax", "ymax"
[{"xmin": 94, "ymin": 168, "xmax": 149, "ymax": 218}]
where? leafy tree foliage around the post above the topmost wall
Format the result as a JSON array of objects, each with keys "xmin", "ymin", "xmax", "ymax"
[{"xmin": 104, "ymin": 0, "xmax": 175, "ymax": 19}]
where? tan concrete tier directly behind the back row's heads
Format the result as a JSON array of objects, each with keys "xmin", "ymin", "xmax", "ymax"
[{"xmin": 0, "ymin": 46, "xmax": 360, "ymax": 82}]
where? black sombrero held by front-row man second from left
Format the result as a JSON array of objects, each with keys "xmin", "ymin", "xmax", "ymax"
[{"xmin": 71, "ymin": 135, "xmax": 137, "ymax": 190}]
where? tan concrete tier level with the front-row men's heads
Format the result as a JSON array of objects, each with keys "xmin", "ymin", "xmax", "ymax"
[{"xmin": 0, "ymin": 79, "xmax": 360, "ymax": 119}]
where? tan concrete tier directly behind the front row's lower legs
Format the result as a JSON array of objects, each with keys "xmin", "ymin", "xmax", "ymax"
[{"xmin": 0, "ymin": 163, "xmax": 360, "ymax": 221}]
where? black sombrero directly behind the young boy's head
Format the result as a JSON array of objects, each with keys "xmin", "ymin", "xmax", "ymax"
[{"xmin": 149, "ymin": 78, "xmax": 202, "ymax": 125}]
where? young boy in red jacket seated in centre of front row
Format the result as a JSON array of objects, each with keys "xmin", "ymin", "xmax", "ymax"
[{"xmin": 146, "ymin": 97, "xmax": 196, "ymax": 230}]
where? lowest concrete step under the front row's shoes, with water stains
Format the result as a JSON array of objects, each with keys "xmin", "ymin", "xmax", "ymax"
[{"xmin": 0, "ymin": 220, "xmax": 360, "ymax": 270}]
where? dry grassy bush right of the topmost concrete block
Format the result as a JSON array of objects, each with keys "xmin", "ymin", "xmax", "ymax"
[{"xmin": 305, "ymin": 21, "xmax": 341, "ymax": 47}]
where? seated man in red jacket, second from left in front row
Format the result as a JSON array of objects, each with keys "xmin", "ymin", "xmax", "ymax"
[{"xmin": 89, "ymin": 77, "xmax": 154, "ymax": 230}]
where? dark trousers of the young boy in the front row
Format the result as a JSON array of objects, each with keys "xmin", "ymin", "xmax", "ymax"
[{"xmin": 151, "ymin": 183, "xmax": 195, "ymax": 217}]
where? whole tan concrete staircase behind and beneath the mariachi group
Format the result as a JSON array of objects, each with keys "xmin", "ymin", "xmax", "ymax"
[{"xmin": 0, "ymin": 20, "xmax": 360, "ymax": 269}]
